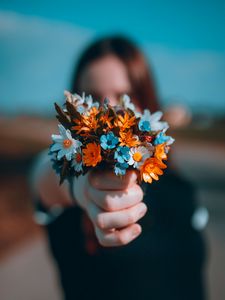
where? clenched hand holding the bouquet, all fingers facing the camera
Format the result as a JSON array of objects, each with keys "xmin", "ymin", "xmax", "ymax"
[{"xmin": 74, "ymin": 171, "xmax": 147, "ymax": 247}]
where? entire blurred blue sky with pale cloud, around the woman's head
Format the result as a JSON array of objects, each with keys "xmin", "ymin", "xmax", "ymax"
[{"xmin": 0, "ymin": 0, "xmax": 225, "ymax": 113}]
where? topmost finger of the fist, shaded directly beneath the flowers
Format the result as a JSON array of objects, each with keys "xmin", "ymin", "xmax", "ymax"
[{"xmin": 89, "ymin": 170, "xmax": 137, "ymax": 191}]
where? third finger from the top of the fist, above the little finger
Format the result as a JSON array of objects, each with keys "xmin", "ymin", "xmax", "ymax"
[{"xmin": 88, "ymin": 202, "xmax": 147, "ymax": 230}]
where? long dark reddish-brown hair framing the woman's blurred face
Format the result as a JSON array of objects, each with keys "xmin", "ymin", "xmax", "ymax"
[{"xmin": 72, "ymin": 36, "xmax": 159, "ymax": 112}]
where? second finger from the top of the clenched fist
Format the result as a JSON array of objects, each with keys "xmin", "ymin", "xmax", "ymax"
[{"xmin": 86, "ymin": 184, "xmax": 143, "ymax": 211}]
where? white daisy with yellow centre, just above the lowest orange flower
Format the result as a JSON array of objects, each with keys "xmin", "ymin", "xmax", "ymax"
[{"xmin": 128, "ymin": 146, "xmax": 152, "ymax": 168}]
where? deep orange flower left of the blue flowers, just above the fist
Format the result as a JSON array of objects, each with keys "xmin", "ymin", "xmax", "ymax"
[{"xmin": 83, "ymin": 143, "xmax": 102, "ymax": 167}]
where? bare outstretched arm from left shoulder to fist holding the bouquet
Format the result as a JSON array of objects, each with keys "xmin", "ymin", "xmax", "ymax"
[{"xmin": 34, "ymin": 154, "xmax": 147, "ymax": 247}]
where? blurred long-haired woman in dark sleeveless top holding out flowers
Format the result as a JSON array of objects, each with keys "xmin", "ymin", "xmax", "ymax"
[{"xmin": 33, "ymin": 36, "xmax": 204, "ymax": 300}]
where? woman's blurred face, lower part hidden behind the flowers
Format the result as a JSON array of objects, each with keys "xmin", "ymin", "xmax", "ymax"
[{"xmin": 80, "ymin": 55, "xmax": 131, "ymax": 105}]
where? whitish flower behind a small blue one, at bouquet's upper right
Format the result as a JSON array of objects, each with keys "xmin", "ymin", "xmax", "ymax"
[{"xmin": 139, "ymin": 109, "xmax": 168, "ymax": 131}]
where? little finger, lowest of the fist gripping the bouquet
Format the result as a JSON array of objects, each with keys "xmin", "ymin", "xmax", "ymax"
[{"xmin": 95, "ymin": 224, "xmax": 141, "ymax": 247}]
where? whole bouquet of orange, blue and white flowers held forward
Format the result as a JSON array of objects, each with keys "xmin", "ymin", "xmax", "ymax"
[{"xmin": 50, "ymin": 91, "xmax": 174, "ymax": 183}]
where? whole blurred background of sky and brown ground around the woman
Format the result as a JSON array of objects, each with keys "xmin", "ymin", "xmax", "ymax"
[{"xmin": 0, "ymin": 0, "xmax": 225, "ymax": 300}]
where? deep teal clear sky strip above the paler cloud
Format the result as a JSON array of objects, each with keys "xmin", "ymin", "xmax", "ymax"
[{"xmin": 0, "ymin": 0, "xmax": 225, "ymax": 51}]
